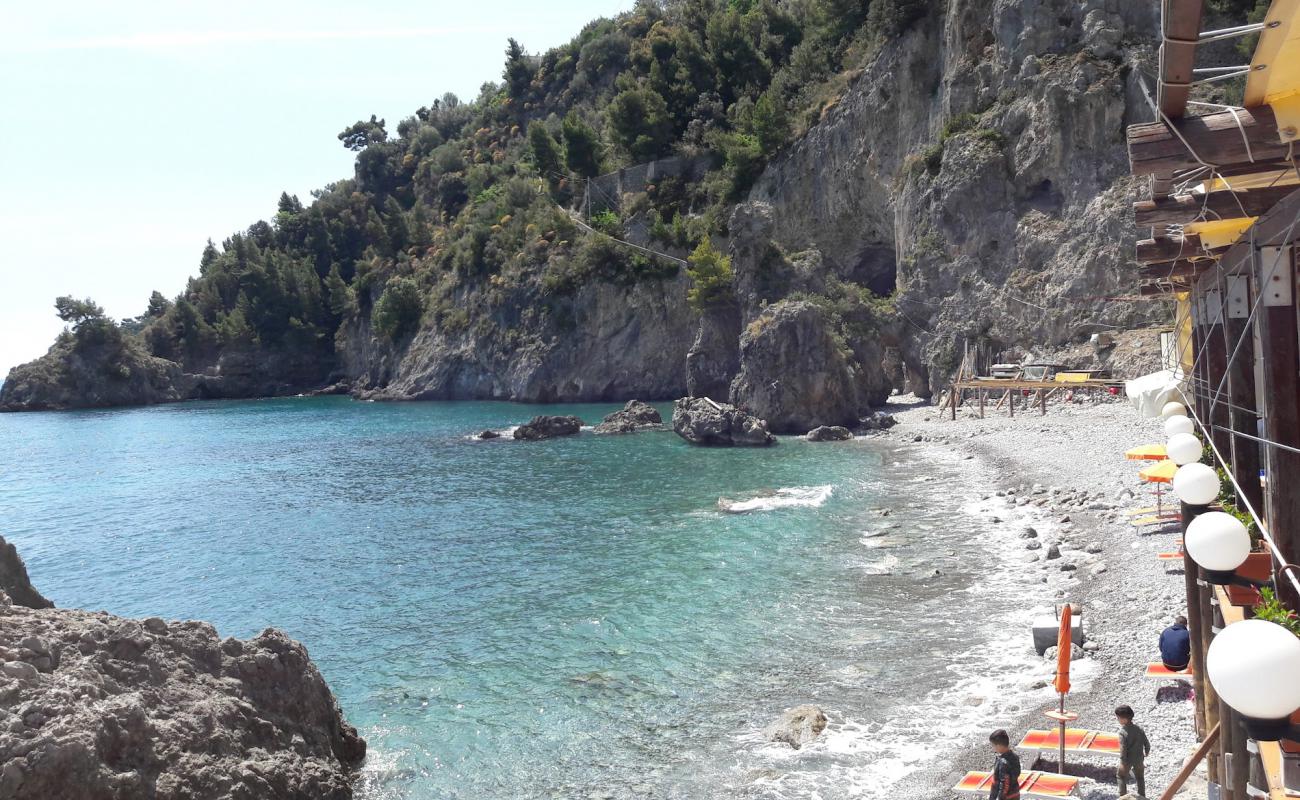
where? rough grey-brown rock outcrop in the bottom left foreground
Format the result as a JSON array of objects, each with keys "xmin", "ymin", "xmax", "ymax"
[{"xmin": 0, "ymin": 539, "xmax": 365, "ymax": 800}]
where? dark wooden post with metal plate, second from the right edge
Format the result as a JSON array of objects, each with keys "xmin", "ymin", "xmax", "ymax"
[{"xmin": 1223, "ymin": 274, "xmax": 1264, "ymax": 514}]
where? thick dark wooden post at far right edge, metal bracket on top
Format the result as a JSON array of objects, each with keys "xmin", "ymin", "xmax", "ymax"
[{"xmin": 1256, "ymin": 245, "xmax": 1300, "ymax": 609}]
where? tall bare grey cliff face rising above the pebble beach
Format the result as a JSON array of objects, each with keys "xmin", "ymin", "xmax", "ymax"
[{"xmin": 733, "ymin": 0, "xmax": 1167, "ymax": 392}]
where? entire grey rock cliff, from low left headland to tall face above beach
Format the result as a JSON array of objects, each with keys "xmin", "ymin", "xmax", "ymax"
[{"xmin": 0, "ymin": 0, "xmax": 1167, "ymax": 421}]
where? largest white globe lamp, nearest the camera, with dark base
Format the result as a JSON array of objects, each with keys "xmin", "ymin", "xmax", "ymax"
[{"xmin": 1205, "ymin": 619, "xmax": 1300, "ymax": 741}]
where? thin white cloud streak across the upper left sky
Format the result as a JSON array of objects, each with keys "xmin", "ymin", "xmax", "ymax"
[{"xmin": 4, "ymin": 26, "xmax": 493, "ymax": 53}]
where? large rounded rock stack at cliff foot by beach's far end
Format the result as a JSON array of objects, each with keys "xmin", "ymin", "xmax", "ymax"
[{"xmin": 731, "ymin": 300, "xmax": 858, "ymax": 433}]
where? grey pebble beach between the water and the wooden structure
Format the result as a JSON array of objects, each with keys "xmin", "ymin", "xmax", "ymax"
[{"xmin": 884, "ymin": 395, "xmax": 1205, "ymax": 800}]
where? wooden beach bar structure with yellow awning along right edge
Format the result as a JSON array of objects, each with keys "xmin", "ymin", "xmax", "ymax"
[{"xmin": 1127, "ymin": 0, "xmax": 1300, "ymax": 800}]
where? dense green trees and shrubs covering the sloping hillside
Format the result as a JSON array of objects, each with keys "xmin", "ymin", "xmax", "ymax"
[{"xmin": 7, "ymin": 0, "xmax": 927, "ymax": 411}]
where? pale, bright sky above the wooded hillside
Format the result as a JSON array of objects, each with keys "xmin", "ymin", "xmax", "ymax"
[{"xmin": 0, "ymin": 0, "xmax": 633, "ymax": 377}]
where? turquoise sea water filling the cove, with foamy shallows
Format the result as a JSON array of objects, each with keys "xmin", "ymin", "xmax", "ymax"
[{"xmin": 0, "ymin": 398, "xmax": 1003, "ymax": 800}]
